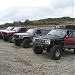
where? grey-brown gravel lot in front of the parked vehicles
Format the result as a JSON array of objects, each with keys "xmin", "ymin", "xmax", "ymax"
[{"xmin": 0, "ymin": 40, "xmax": 75, "ymax": 75}]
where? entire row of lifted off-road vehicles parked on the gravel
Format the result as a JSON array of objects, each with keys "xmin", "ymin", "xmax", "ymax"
[{"xmin": 1, "ymin": 25, "xmax": 75, "ymax": 60}]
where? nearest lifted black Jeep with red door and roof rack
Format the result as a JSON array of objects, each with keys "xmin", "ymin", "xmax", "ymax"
[{"xmin": 33, "ymin": 26, "xmax": 75, "ymax": 60}]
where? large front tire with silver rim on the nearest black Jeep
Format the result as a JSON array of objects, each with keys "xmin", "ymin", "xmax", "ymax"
[{"xmin": 50, "ymin": 45, "xmax": 62, "ymax": 60}]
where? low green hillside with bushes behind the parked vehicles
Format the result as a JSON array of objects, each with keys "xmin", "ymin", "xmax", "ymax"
[{"xmin": 0, "ymin": 17, "xmax": 75, "ymax": 28}]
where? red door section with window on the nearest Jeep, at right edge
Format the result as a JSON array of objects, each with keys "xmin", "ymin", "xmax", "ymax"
[{"xmin": 64, "ymin": 30, "xmax": 75, "ymax": 53}]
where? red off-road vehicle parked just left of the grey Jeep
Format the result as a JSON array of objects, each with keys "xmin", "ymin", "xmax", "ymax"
[{"xmin": 2, "ymin": 27, "xmax": 26, "ymax": 43}]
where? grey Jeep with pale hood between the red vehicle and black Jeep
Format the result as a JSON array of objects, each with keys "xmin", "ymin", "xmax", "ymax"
[{"xmin": 14, "ymin": 28, "xmax": 50, "ymax": 48}]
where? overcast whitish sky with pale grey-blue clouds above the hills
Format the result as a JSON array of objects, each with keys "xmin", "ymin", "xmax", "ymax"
[{"xmin": 0, "ymin": 0, "xmax": 75, "ymax": 24}]
